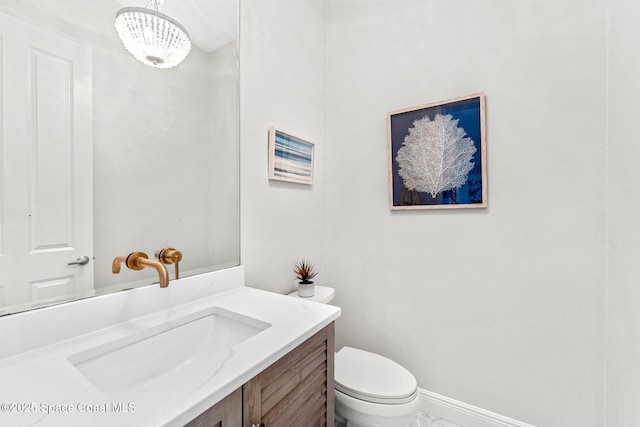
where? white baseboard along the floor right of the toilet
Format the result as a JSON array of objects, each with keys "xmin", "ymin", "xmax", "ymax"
[{"xmin": 419, "ymin": 389, "xmax": 535, "ymax": 427}]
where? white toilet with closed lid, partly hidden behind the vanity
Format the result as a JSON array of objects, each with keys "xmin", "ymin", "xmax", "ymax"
[{"xmin": 289, "ymin": 286, "xmax": 420, "ymax": 427}]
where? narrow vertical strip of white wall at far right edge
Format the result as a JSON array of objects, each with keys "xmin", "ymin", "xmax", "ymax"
[{"xmin": 607, "ymin": 0, "xmax": 640, "ymax": 427}]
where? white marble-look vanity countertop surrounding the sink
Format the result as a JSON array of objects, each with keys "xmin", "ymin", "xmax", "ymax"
[{"xmin": 0, "ymin": 286, "xmax": 340, "ymax": 426}]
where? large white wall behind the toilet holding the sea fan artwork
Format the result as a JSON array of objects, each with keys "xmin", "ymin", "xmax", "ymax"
[{"xmin": 327, "ymin": 0, "xmax": 607, "ymax": 427}]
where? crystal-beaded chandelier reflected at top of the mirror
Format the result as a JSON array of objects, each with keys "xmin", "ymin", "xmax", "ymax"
[{"xmin": 115, "ymin": 0, "xmax": 191, "ymax": 68}]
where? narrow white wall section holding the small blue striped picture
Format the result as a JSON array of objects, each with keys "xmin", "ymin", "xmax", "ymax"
[{"xmin": 240, "ymin": 0, "xmax": 328, "ymax": 292}]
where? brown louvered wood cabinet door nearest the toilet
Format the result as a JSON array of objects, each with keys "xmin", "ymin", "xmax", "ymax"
[{"xmin": 243, "ymin": 323, "xmax": 335, "ymax": 427}]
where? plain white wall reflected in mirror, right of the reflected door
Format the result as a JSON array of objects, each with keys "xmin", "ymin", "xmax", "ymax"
[{"xmin": 93, "ymin": 29, "xmax": 211, "ymax": 287}]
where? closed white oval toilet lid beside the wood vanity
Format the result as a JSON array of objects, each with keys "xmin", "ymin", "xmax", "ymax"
[{"xmin": 335, "ymin": 347, "xmax": 418, "ymax": 403}]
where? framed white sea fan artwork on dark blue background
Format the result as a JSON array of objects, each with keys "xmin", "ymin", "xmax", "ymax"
[{"xmin": 387, "ymin": 93, "xmax": 487, "ymax": 210}]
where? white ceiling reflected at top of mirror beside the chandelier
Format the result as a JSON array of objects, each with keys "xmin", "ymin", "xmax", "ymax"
[{"xmin": 116, "ymin": 0, "xmax": 238, "ymax": 53}]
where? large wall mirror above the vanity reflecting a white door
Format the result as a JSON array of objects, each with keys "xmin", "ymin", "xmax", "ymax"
[{"xmin": 0, "ymin": 0, "xmax": 240, "ymax": 315}]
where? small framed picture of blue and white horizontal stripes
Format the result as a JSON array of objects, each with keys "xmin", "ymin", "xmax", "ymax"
[{"xmin": 268, "ymin": 127, "xmax": 314, "ymax": 185}]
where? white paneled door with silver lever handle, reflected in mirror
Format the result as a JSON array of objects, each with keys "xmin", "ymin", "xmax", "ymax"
[{"xmin": 0, "ymin": 13, "xmax": 93, "ymax": 311}]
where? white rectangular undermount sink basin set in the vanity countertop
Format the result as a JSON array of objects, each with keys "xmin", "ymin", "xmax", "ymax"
[{"xmin": 68, "ymin": 307, "xmax": 271, "ymax": 393}]
